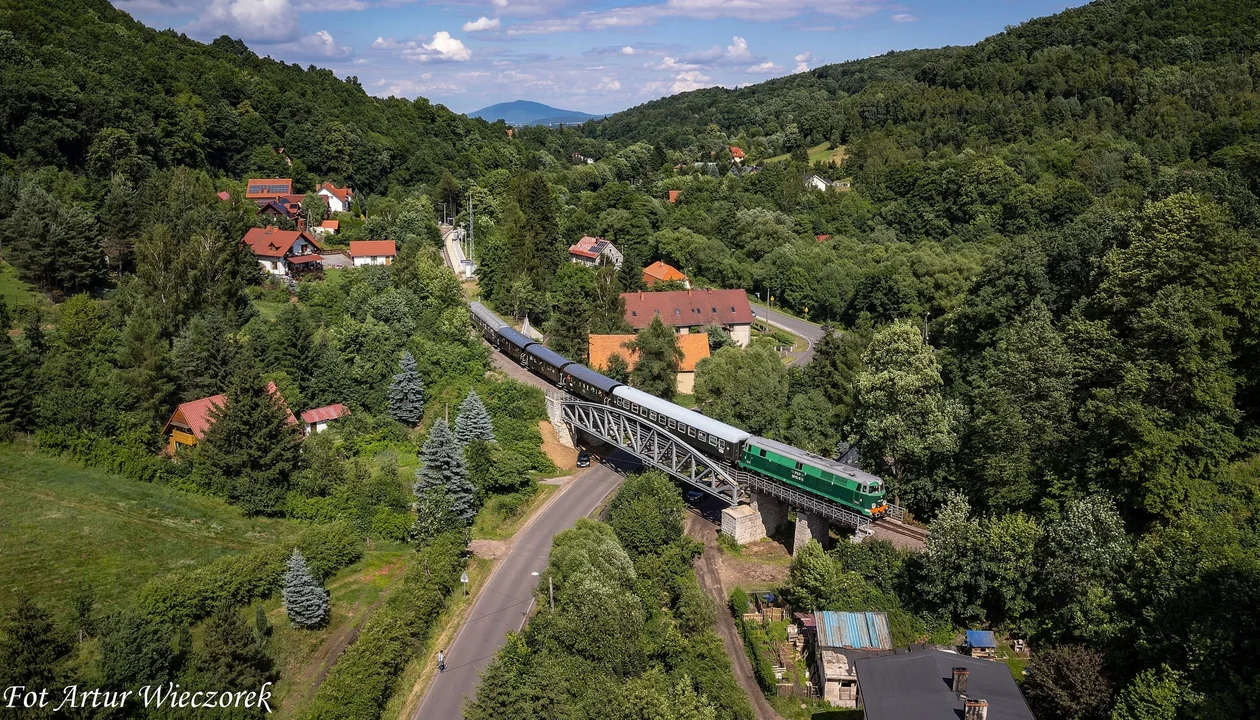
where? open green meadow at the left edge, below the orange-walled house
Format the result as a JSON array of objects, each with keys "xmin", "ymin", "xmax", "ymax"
[{"xmin": 0, "ymin": 445, "xmax": 297, "ymax": 612}]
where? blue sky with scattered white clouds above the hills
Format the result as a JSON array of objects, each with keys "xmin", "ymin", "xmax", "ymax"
[{"xmin": 115, "ymin": 0, "xmax": 1082, "ymax": 112}]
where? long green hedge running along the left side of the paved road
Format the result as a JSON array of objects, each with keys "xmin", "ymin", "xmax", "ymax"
[{"xmin": 301, "ymin": 532, "xmax": 465, "ymax": 720}]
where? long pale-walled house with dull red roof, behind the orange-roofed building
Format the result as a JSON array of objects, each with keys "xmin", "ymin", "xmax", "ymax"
[{"xmin": 621, "ymin": 290, "xmax": 752, "ymax": 348}]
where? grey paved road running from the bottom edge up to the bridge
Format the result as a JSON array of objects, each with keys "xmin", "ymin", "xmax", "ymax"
[{"xmin": 411, "ymin": 465, "xmax": 621, "ymax": 720}]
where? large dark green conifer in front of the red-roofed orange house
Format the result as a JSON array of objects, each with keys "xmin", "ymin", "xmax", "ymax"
[{"xmin": 197, "ymin": 359, "xmax": 299, "ymax": 514}]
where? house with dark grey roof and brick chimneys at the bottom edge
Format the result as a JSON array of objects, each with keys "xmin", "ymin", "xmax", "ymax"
[{"xmin": 854, "ymin": 646, "xmax": 1033, "ymax": 720}]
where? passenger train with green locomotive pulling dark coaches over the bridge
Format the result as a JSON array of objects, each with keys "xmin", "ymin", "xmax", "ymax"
[{"xmin": 469, "ymin": 303, "xmax": 888, "ymax": 518}]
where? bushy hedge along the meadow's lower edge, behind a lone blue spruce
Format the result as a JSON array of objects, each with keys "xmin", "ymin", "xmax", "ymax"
[{"xmin": 136, "ymin": 522, "xmax": 363, "ymax": 624}]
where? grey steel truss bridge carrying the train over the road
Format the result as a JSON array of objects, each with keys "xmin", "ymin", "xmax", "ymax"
[{"xmin": 547, "ymin": 392, "xmax": 901, "ymax": 536}]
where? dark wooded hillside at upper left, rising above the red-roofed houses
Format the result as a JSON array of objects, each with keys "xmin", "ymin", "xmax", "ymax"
[{"xmin": 0, "ymin": 0, "xmax": 519, "ymax": 192}]
